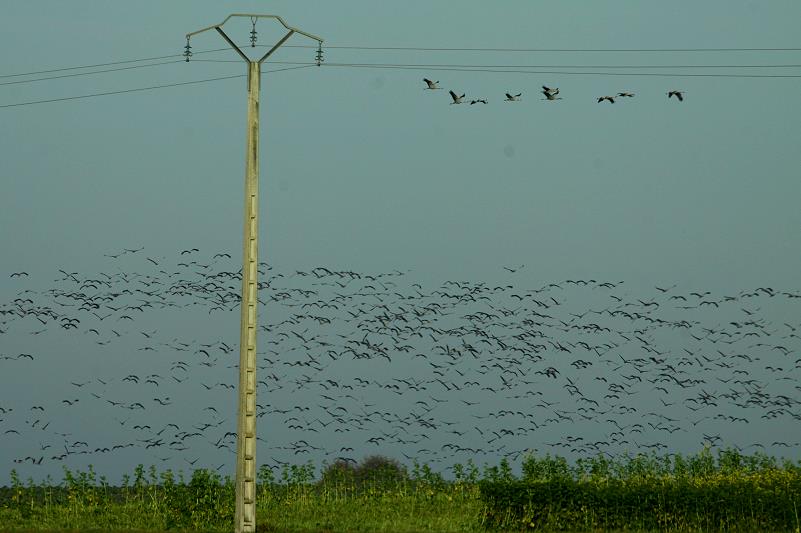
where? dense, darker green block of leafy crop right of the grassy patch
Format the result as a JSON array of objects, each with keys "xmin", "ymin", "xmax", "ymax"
[{"xmin": 479, "ymin": 447, "xmax": 801, "ymax": 531}]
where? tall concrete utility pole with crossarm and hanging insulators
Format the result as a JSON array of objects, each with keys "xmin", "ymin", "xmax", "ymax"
[{"xmin": 184, "ymin": 14, "xmax": 323, "ymax": 533}]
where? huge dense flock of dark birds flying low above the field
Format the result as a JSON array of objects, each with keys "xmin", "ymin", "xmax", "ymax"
[{"xmin": 0, "ymin": 248, "xmax": 801, "ymax": 473}]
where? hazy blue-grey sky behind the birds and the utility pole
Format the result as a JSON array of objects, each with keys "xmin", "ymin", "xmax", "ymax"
[{"xmin": 0, "ymin": 0, "xmax": 801, "ymax": 483}]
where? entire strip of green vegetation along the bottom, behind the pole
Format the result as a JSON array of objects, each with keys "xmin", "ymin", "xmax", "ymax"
[{"xmin": 0, "ymin": 449, "xmax": 801, "ymax": 533}]
